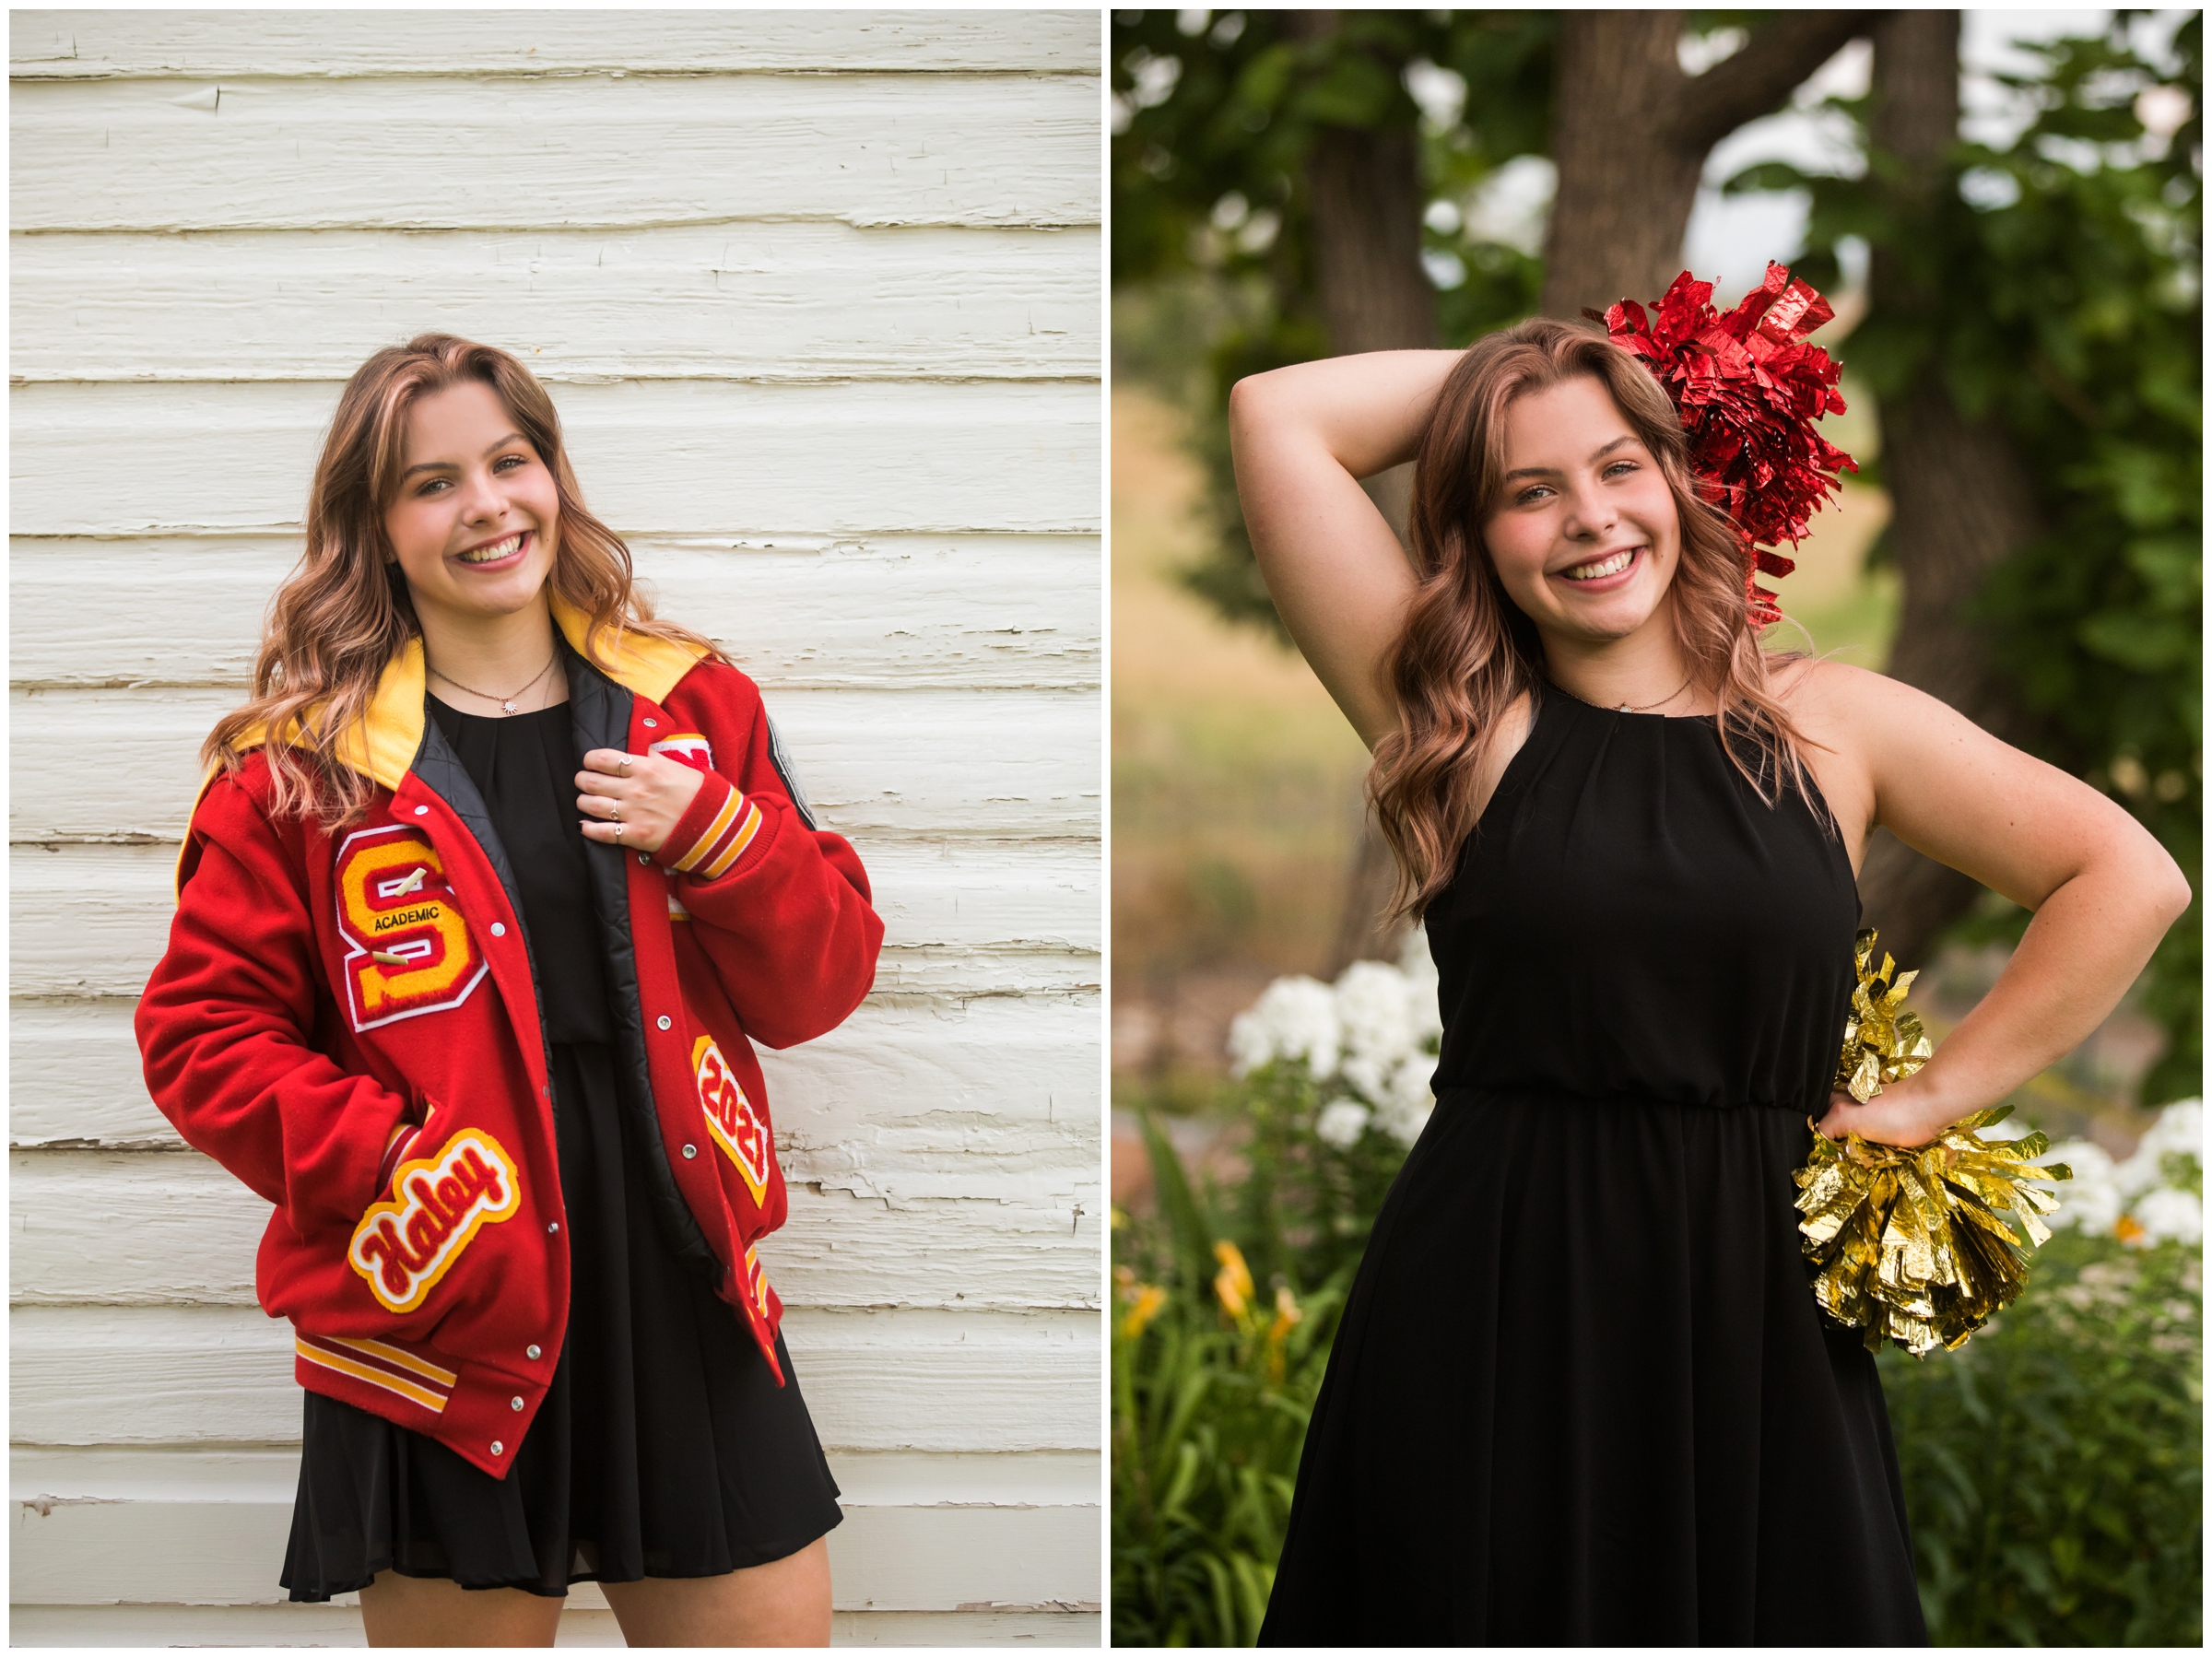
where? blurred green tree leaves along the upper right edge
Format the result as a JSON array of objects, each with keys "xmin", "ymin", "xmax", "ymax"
[{"xmin": 1727, "ymin": 13, "xmax": 2203, "ymax": 1104}]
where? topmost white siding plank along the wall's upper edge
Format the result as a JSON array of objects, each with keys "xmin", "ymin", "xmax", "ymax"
[{"xmin": 9, "ymin": 11, "xmax": 1101, "ymax": 79}]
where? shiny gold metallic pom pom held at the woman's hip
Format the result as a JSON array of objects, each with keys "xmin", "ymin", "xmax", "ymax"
[{"xmin": 1796, "ymin": 932, "xmax": 2073, "ymax": 1358}]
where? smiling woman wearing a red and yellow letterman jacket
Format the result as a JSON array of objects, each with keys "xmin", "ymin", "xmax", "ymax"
[{"xmin": 137, "ymin": 334, "xmax": 883, "ymax": 1646}]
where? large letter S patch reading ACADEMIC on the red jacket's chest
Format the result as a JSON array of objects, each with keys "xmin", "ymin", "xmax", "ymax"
[{"xmin": 338, "ymin": 823, "xmax": 491, "ymax": 1031}]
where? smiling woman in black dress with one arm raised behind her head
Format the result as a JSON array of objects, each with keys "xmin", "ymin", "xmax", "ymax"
[{"xmin": 1230, "ymin": 319, "xmax": 2188, "ymax": 1646}]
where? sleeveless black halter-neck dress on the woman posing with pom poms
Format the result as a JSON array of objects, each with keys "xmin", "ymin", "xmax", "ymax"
[{"xmin": 1261, "ymin": 690, "xmax": 1926, "ymax": 1646}]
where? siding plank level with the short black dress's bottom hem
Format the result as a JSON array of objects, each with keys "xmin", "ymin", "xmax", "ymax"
[{"xmin": 9, "ymin": 1498, "xmax": 1101, "ymax": 1611}]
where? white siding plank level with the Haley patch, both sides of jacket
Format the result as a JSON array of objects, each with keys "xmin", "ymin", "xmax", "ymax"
[{"xmin": 9, "ymin": 1141, "xmax": 1104, "ymax": 1312}]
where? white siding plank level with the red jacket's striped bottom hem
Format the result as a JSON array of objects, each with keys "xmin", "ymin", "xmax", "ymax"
[{"xmin": 9, "ymin": 1305, "xmax": 1104, "ymax": 1453}]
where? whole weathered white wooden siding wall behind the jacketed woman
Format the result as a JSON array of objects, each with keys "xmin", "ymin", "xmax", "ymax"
[{"xmin": 9, "ymin": 11, "xmax": 1104, "ymax": 1646}]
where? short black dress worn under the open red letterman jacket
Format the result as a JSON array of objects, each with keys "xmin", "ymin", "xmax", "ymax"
[{"xmin": 281, "ymin": 699, "xmax": 841, "ymax": 1600}]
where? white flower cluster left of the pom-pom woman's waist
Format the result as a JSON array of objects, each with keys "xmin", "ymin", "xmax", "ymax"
[{"xmin": 1230, "ymin": 929, "xmax": 1444, "ymax": 1150}]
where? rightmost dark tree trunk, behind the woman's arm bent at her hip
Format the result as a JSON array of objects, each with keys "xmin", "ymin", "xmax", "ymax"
[{"xmin": 1858, "ymin": 11, "xmax": 2041, "ymax": 967}]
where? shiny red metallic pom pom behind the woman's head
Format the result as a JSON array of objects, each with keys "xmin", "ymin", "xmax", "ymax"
[{"xmin": 1593, "ymin": 265, "xmax": 1858, "ymax": 626}]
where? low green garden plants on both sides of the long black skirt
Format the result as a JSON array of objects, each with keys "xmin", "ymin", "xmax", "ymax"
[{"xmin": 1112, "ymin": 1084, "xmax": 2203, "ymax": 1646}]
